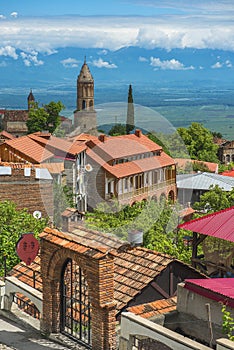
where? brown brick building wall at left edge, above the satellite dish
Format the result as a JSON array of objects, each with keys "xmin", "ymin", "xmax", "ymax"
[{"xmin": 0, "ymin": 169, "xmax": 53, "ymax": 219}]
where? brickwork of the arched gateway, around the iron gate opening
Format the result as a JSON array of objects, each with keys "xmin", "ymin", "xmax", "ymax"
[{"xmin": 41, "ymin": 234, "xmax": 116, "ymax": 350}]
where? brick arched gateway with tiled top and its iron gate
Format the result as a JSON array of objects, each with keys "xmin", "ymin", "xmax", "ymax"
[{"xmin": 40, "ymin": 228, "xmax": 116, "ymax": 350}]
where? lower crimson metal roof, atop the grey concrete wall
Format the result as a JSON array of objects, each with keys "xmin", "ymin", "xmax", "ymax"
[{"xmin": 185, "ymin": 278, "xmax": 234, "ymax": 307}]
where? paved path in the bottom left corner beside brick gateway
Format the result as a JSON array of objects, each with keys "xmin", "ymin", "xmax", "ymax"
[{"xmin": 0, "ymin": 316, "xmax": 73, "ymax": 350}]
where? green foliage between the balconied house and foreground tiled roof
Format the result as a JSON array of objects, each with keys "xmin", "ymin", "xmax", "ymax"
[{"xmin": 86, "ymin": 201, "xmax": 191, "ymax": 263}]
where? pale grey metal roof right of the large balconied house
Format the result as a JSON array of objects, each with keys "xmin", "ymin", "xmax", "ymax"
[{"xmin": 176, "ymin": 172, "xmax": 234, "ymax": 191}]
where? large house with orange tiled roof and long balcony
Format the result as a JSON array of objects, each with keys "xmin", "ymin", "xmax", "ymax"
[{"xmin": 83, "ymin": 130, "xmax": 176, "ymax": 209}]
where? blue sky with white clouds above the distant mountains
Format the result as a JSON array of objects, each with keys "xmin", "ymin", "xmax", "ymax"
[{"xmin": 0, "ymin": 0, "xmax": 234, "ymax": 69}]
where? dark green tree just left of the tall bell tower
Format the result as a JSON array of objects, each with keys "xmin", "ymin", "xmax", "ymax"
[{"xmin": 26, "ymin": 101, "xmax": 65, "ymax": 134}]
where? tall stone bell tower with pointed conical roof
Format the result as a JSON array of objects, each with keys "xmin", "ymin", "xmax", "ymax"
[{"xmin": 74, "ymin": 59, "xmax": 97, "ymax": 133}]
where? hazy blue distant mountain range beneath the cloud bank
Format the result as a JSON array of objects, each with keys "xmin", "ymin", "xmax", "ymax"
[{"xmin": 0, "ymin": 47, "xmax": 234, "ymax": 89}]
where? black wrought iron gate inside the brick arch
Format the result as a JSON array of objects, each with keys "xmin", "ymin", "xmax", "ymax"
[{"xmin": 60, "ymin": 259, "xmax": 91, "ymax": 349}]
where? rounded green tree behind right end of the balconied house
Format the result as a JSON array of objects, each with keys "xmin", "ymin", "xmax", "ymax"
[{"xmin": 177, "ymin": 123, "xmax": 218, "ymax": 162}]
